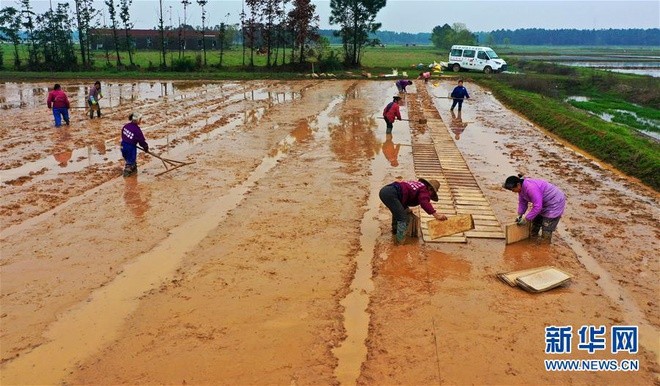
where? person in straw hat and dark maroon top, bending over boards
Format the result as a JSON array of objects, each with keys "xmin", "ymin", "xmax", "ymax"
[{"xmin": 378, "ymin": 178, "xmax": 447, "ymax": 244}]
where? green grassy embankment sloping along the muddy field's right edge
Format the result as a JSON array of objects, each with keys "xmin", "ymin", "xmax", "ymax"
[{"xmin": 475, "ymin": 65, "xmax": 660, "ymax": 190}]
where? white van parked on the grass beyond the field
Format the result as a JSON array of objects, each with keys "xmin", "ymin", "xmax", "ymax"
[{"xmin": 447, "ymin": 45, "xmax": 506, "ymax": 74}]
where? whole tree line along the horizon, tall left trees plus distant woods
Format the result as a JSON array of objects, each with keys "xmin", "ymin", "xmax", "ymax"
[{"xmin": 0, "ymin": 0, "xmax": 660, "ymax": 71}]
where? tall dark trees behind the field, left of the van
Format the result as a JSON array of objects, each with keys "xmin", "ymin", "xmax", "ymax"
[{"xmin": 0, "ymin": 0, "xmax": 386, "ymax": 71}]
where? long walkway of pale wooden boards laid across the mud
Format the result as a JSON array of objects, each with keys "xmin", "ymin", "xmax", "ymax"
[{"xmin": 407, "ymin": 87, "xmax": 505, "ymax": 243}]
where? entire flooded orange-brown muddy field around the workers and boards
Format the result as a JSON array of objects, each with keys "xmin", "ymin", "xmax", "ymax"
[{"xmin": 0, "ymin": 80, "xmax": 660, "ymax": 385}]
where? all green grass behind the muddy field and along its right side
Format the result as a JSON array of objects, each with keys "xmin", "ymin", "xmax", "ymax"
[{"xmin": 0, "ymin": 45, "xmax": 660, "ymax": 190}]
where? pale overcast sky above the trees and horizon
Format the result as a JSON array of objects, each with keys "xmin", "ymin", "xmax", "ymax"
[{"xmin": 23, "ymin": 0, "xmax": 660, "ymax": 33}]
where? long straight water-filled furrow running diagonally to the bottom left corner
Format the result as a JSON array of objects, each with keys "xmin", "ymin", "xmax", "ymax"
[{"xmin": 2, "ymin": 99, "xmax": 314, "ymax": 384}]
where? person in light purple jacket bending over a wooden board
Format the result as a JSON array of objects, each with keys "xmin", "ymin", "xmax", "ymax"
[{"xmin": 503, "ymin": 174, "xmax": 566, "ymax": 243}]
